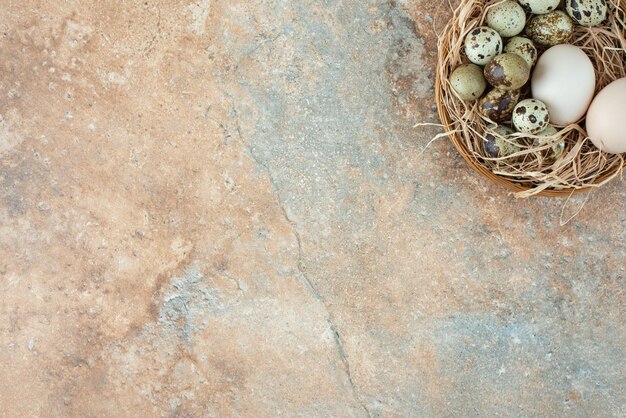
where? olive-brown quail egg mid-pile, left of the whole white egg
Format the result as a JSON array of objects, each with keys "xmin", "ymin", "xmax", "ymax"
[{"xmin": 485, "ymin": 53, "xmax": 530, "ymax": 90}]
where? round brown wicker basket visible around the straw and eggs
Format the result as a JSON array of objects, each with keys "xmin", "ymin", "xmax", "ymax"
[{"xmin": 435, "ymin": 0, "xmax": 626, "ymax": 197}]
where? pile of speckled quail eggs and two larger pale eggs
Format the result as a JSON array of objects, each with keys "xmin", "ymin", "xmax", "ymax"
[{"xmin": 450, "ymin": 0, "xmax": 626, "ymax": 158}]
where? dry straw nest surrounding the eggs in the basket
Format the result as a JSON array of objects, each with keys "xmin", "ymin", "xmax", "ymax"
[{"xmin": 435, "ymin": 0, "xmax": 626, "ymax": 197}]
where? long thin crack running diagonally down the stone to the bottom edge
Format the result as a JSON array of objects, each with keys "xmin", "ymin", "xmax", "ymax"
[{"xmin": 226, "ymin": 97, "xmax": 372, "ymax": 417}]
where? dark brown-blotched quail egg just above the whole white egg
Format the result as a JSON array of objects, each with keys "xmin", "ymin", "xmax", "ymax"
[{"xmin": 526, "ymin": 10, "xmax": 574, "ymax": 46}]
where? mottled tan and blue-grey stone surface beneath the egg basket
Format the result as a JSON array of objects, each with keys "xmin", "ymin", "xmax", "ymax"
[{"xmin": 0, "ymin": 0, "xmax": 626, "ymax": 417}]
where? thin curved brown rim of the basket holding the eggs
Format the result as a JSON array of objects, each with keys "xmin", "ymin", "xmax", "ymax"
[{"xmin": 435, "ymin": 0, "xmax": 626, "ymax": 197}]
